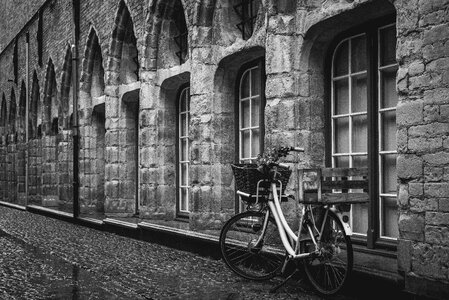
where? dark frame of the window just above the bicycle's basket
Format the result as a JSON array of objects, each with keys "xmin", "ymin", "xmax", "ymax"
[{"xmin": 234, "ymin": 56, "xmax": 266, "ymax": 212}]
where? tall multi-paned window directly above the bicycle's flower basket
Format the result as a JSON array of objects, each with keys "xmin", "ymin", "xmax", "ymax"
[{"xmin": 238, "ymin": 62, "xmax": 265, "ymax": 162}]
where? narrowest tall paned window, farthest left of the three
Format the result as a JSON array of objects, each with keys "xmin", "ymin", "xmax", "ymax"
[{"xmin": 178, "ymin": 87, "xmax": 190, "ymax": 214}]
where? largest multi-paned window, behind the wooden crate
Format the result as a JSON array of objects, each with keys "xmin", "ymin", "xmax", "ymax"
[{"xmin": 330, "ymin": 24, "xmax": 398, "ymax": 241}]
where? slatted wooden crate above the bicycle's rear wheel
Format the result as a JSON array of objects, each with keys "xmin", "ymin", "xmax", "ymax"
[{"xmin": 298, "ymin": 168, "xmax": 369, "ymax": 204}]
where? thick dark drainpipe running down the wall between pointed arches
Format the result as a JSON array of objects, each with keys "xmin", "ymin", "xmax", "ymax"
[{"xmin": 72, "ymin": 0, "xmax": 80, "ymax": 218}]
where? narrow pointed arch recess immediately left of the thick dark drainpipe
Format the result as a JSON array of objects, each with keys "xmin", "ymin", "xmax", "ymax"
[{"xmin": 58, "ymin": 45, "xmax": 73, "ymax": 129}]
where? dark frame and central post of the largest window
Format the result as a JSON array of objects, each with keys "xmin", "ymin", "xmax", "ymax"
[{"xmin": 324, "ymin": 14, "xmax": 397, "ymax": 250}]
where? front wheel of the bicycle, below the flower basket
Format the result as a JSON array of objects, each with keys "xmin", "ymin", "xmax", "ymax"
[{"xmin": 219, "ymin": 211, "xmax": 283, "ymax": 280}]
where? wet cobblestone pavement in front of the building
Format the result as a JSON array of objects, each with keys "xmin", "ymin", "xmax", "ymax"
[{"xmin": 0, "ymin": 206, "xmax": 354, "ymax": 299}]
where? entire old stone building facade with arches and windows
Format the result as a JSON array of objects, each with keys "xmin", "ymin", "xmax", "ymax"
[{"xmin": 0, "ymin": 0, "xmax": 449, "ymax": 298}]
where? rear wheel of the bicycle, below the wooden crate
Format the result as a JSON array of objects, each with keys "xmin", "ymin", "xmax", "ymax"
[{"xmin": 303, "ymin": 211, "xmax": 353, "ymax": 295}]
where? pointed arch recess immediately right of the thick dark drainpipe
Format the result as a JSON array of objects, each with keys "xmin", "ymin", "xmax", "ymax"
[{"xmin": 81, "ymin": 27, "xmax": 104, "ymax": 97}]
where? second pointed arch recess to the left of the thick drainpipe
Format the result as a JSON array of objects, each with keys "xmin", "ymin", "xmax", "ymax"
[{"xmin": 42, "ymin": 58, "xmax": 59, "ymax": 135}]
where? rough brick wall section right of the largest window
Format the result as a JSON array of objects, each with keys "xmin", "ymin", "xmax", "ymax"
[{"xmin": 397, "ymin": 1, "xmax": 449, "ymax": 297}]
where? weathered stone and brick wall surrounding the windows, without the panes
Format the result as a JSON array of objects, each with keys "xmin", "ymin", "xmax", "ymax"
[{"xmin": 0, "ymin": 0, "xmax": 449, "ymax": 297}]
